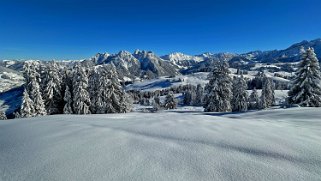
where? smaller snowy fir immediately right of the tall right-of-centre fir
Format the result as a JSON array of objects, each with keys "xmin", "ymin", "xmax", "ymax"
[{"xmin": 232, "ymin": 76, "xmax": 248, "ymax": 112}]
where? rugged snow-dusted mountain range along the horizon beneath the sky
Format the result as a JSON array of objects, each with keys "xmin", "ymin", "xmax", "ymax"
[{"xmin": 0, "ymin": 39, "xmax": 321, "ymax": 81}]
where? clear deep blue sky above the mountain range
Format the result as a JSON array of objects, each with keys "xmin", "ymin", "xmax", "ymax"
[{"xmin": 0, "ymin": 0, "xmax": 321, "ymax": 60}]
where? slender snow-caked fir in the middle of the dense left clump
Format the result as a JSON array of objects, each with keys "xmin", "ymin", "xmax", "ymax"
[{"xmin": 72, "ymin": 64, "xmax": 90, "ymax": 114}]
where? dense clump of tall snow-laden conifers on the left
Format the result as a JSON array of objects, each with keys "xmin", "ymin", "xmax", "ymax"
[{"xmin": 15, "ymin": 61, "xmax": 131, "ymax": 117}]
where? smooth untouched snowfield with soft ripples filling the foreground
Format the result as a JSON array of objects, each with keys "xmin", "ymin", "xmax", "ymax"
[{"xmin": 0, "ymin": 108, "xmax": 321, "ymax": 181}]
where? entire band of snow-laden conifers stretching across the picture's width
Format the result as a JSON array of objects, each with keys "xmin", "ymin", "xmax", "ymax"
[{"xmin": 0, "ymin": 48, "xmax": 321, "ymax": 119}]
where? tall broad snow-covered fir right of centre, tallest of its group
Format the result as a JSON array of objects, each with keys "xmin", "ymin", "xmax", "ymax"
[{"xmin": 203, "ymin": 61, "xmax": 232, "ymax": 112}]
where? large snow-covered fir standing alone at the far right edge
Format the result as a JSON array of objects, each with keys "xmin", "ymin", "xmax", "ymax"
[{"xmin": 288, "ymin": 48, "xmax": 321, "ymax": 107}]
